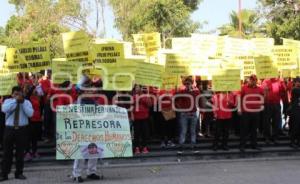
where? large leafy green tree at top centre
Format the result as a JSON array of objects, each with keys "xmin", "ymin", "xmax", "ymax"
[{"xmin": 109, "ymin": 0, "xmax": 201, "ymax": 43}]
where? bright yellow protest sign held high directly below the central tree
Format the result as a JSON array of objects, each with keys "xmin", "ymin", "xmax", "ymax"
[{"xmin": 133, "ymin": 32, "xmax": 161, "ymax": 56}]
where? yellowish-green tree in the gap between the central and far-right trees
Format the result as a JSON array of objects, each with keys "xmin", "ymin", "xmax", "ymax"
[{"xmin": 219, "ymin": 9, "xmax": 263, "ymax": 38}]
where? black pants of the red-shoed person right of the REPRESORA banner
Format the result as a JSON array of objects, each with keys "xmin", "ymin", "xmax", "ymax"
[{"xmin": 133, "ymin": 120, "xmax": 149, "ymax": 147}]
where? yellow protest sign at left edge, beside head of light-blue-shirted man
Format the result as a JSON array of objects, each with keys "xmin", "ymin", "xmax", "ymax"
[{"xmin": 0, "ymin": 72, "xmax": 18, "ymax": 96}]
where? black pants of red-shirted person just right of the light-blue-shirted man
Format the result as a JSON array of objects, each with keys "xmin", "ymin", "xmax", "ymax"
[{"xmin": 26, "ymin": 122, "xmax": 42, "ymax": 154}]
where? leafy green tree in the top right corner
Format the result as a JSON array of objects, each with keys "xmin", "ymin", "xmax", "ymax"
[{"xmin": 259, "ymin": 0, "xmax": 300, "ymax": 44}]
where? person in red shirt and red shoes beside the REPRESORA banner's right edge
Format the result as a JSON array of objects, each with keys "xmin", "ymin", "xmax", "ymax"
[{"xmin": 132, "ymin": 85, "xmax": 152, "ymax": 154}]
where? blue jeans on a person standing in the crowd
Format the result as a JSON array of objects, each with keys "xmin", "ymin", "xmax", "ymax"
[{"xmin": 179, "ymin": 112, "xmax": 197, "ymax": 144}]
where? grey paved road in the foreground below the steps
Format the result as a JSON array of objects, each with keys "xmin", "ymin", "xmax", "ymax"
[{"xmin": 4, "ymin": 158, "xmax": 300, "ymax": 184}]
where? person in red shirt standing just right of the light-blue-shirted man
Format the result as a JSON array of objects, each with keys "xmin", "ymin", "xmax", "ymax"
[{"xmin": 25, "ymin": 89, "xmax": 42, "ymax": 160}]
